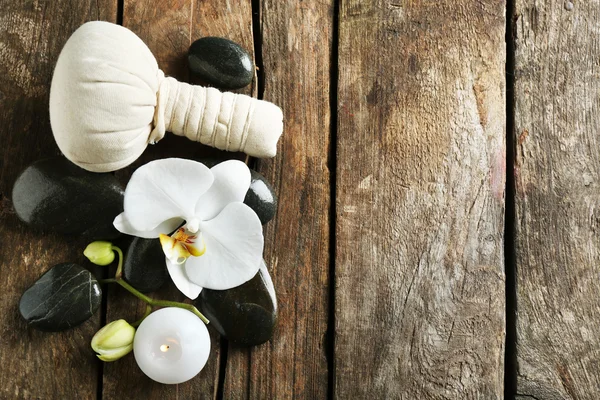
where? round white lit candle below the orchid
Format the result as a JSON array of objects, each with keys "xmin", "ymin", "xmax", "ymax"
[{"xmin": 133, "ymin": 307, "xmax": 210, "ymax": 384}]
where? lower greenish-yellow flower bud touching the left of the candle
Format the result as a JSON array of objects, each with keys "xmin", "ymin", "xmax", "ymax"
[{"xmin": 92, "ymin": 319, "xmax": 135, "ymax": 361}]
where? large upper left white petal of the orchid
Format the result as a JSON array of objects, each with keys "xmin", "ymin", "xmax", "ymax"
[{"xmin": 124, "ymin": 158, "xmax": 214, "ymax": 231}]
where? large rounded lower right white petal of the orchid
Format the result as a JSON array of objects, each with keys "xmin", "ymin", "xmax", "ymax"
[{"xmin": 185, "ymin": 203, "xmax": 264, "ymax": 290}]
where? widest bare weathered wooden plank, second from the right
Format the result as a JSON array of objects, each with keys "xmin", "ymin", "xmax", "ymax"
[{"xmin": 334, "ymin": 0, "xmax": 505, "ymax": 399}]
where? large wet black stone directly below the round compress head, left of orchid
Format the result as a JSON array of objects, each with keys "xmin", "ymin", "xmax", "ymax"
[{"xmin": 12, "ymin": 157, "xmax": 123, "ymax": 240}]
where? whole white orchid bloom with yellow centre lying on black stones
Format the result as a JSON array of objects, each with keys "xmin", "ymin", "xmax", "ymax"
[{"xmin": 114, "ymin": 158, "xmax": 264, "ymax": 299}]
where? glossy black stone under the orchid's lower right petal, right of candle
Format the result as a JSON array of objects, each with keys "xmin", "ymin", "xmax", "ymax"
[{"xmin": 196, "ymin": 263, "xmax": 277, "ymax": 346}]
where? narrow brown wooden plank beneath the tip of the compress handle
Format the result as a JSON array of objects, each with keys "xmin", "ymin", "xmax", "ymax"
[{"xmin": 223, "ymin": 0, "xmax": 334, "ymax": 399}]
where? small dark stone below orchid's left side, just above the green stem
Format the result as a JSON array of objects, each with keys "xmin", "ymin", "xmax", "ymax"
[{"xmin": 123, "ymin": 237, "xmax": 169, "ymax": 293}]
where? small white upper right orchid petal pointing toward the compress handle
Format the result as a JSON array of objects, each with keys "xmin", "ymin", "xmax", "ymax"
[{"xmin": 196, "ymin": 160, "xmax": 250, "ymax": 221}]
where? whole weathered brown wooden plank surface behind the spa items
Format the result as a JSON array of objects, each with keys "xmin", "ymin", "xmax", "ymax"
[{"xmin": 0, "ymin": 0, "xmax": 600, "ymax": 400}]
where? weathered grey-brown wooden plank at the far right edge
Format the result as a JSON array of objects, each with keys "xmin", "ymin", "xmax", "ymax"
[{"xmin": 514, "ymin": 0, "xmax": 600, "ymax": 399}]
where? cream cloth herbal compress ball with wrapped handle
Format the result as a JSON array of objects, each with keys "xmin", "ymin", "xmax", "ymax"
[{"xmin": 50, "ymin": 21, "xmax": 283, "ymax": 172}]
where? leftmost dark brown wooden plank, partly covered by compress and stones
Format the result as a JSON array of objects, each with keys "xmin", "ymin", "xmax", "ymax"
[{"xmin": 0, "ymin": 0, "xmax": 117, "ymax": 399}]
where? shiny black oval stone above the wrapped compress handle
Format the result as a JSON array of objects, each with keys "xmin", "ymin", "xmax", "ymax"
[{"xmin": 188, "ymin": 37, "xmax": 254, "ymax": 89}]
